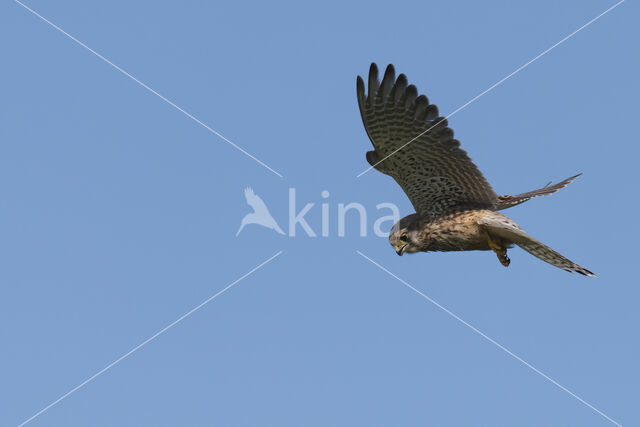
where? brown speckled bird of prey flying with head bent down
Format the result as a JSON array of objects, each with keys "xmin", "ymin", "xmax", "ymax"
[{"xmin": 356, "ymin": 63, "xmax": 595, "ymax": 276}]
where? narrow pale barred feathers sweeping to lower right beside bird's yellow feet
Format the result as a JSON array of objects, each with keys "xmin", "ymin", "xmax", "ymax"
[{"xmin": 478, "ymin": 214, "xmax": 595, "ymax": 276}]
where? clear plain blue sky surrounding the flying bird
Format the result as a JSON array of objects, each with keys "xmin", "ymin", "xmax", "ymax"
[{"xmin": 0, "ymin": 0, "xmax": 640, "ymax": 426}]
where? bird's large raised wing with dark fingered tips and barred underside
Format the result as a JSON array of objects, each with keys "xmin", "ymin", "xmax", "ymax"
[{"xmin": 356, "ymin": 64, "xmax": 498, "ymax": 218}]
